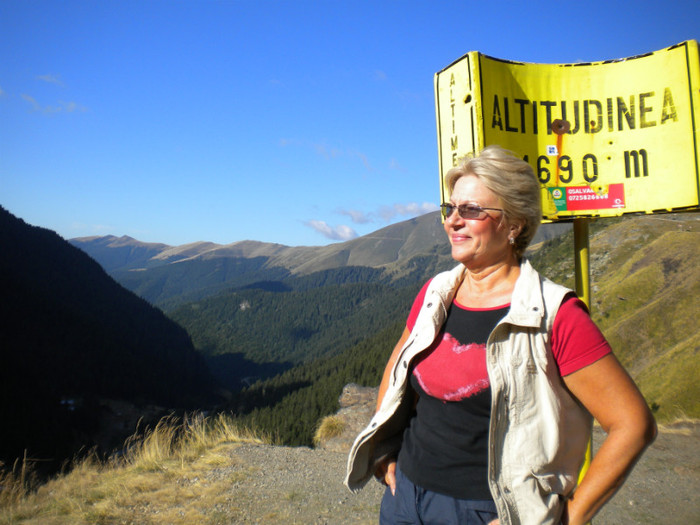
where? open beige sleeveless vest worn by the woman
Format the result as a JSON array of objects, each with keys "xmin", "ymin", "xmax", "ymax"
[{"xmin": 345, "ymin": 260, "xmax": 592, "ymax": 525}]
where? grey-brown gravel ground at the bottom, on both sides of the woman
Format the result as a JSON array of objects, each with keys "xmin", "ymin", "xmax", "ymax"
[{"xmin": 210, "ymin": 423, "xmax": 700, "ymax": 525}]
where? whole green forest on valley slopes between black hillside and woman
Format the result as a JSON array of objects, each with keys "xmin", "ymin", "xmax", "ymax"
[{"xmin": 169, "ymin": 255, "xmax": 454, "ymax": 446}]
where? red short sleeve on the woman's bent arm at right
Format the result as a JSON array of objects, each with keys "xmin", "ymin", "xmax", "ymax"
[{"xmin": 552, "ymin": 295, "xmax": 612, "ymax": 377}]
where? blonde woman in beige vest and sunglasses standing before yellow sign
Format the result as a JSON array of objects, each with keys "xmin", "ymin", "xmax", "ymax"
[{"xmin": 346, "ymin": 146, "xmax": 656, "ymax": 525}]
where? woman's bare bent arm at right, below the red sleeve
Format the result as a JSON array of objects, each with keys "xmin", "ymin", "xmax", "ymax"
[{"xmin": 564, "ymin": 354, "xmax": 656, "ymax": 525}]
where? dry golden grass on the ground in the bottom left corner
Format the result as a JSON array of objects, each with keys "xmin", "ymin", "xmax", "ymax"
[{"xmin": 0, "ymin": 415, "xmax": 268, "ymax": 524}]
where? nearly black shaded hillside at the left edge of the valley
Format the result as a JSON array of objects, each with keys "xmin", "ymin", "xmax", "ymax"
[{"xmin": 0, "ymin": 208, "xmax": 213, "ymax": 470}]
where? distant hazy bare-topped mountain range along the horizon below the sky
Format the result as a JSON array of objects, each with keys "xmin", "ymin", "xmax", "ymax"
[{"xmin": 69, "ymin": 212, "xmax": 571, "ymax": 310}]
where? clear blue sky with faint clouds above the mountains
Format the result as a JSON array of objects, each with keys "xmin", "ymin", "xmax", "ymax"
[{"xmin": 0, "ymin": 0, "xmax": 700, "ymax": 246}]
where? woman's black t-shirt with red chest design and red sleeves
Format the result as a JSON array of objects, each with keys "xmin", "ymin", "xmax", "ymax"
[{"xmin": 399, "ymin": 278, "xmax": 610, "ymax": 500}]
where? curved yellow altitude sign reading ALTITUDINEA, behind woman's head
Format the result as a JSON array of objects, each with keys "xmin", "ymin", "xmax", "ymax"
[{"xmin": 435, "ymin": 40, "xmax": 700, "ymax": 220}]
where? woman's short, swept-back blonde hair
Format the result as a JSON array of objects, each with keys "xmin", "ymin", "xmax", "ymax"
[{"xmin": 445, "ymin": 146, "xmax": 542, "ymax": 259}]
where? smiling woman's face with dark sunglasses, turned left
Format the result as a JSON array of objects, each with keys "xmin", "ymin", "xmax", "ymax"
[{"xmin": 445, "ymin": 175, "xmax": 513, "ymax": 270}]
